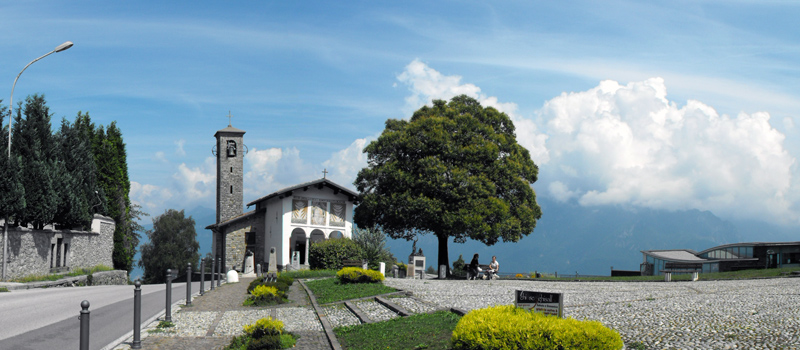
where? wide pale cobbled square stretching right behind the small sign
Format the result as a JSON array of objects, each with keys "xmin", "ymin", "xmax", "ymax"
[{"xmin": 385, "ymin": 278, "xmax": 800, "ymax": 349}]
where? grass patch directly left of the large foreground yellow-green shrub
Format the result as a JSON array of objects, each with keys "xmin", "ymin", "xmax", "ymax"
[{"xmin": 333, "ymin": 311, "xmax": 461, "ymax": 350}]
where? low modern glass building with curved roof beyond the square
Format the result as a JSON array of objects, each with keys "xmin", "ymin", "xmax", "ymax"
[{"xmin": 640, "ymin": 242, "xmax": 800, "ymax": 276}]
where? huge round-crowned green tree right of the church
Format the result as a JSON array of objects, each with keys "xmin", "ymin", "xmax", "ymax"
[{"xmin": 354, "ymin": 95, "xmax": 542, "ymax": 274}]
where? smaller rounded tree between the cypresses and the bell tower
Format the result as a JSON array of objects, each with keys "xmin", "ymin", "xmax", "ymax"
[{"xmin": 139, "ymin": 209, "xmax": 200, "ymax": 283}]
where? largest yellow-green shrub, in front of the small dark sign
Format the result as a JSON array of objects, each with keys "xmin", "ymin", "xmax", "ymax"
[{"xmin": 452, "ymin": 305, "xmax": 622, "ymax": 350}]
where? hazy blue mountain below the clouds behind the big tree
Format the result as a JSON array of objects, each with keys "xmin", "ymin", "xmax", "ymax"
[{"xmin": 387, "ymin": 197, "xmax": 798, "ymax": 276}]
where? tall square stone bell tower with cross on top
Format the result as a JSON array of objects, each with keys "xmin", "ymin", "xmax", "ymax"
[{"xmin": 212, "ymin": 112, "xmax": 247, "ymax": 223}]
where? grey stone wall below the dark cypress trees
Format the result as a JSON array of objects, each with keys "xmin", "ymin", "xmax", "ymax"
[{"xmin": 0, "ymin": 215, "xmax": 115, "ymax": 279}]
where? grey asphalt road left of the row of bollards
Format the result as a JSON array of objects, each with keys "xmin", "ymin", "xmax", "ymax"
[{"xmin": 0, "ymin": 281, "xmax": 210, "ymax": 350}]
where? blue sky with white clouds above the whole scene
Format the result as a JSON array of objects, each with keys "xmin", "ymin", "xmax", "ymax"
[{"xmin": 0, "ymin": 1, "xmax": 800, "ymax": 230}]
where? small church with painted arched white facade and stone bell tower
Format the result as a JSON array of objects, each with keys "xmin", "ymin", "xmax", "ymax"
[{"xmin": 206, "ymin": 124, "xmax": 358, "ymax": 272}]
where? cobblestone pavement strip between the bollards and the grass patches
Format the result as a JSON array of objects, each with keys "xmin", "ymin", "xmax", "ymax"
[{"xmin": 114, "ymin": 278, "xmax": 330, "ymax": 350}]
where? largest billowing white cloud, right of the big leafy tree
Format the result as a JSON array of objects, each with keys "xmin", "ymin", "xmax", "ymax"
[{"xmin": 397, "ymin": 60, "xmax": 800, "ymax": 222}]
